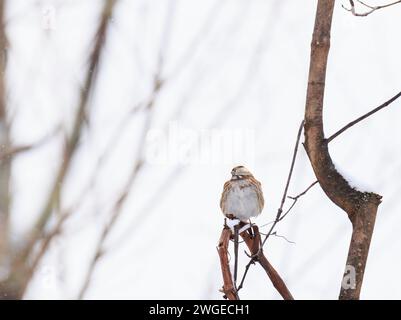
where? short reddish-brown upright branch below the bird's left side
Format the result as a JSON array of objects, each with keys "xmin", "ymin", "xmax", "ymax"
[{"xmin": 217, "ymin": 227, "xmax": 239, "ymax": 300}]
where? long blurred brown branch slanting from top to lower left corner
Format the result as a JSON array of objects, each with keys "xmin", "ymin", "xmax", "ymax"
[{"xmin": 0, "ymin": 0, "xmax": 116, "ymax": 298}]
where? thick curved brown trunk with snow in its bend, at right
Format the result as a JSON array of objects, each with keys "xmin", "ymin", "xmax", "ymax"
[{"xmin": 305, "ymin": 0, "xmax": 381, "ymax": 299}]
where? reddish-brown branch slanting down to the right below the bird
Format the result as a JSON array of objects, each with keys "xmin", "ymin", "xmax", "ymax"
[{"xmin": 240, "ymin": 225, "xmax": 294, "ymax": 300}]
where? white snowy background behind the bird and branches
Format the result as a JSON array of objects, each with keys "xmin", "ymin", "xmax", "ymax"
[{"xmin": 6, "ymin": 0, "xmax": 401, "ymax": 299}]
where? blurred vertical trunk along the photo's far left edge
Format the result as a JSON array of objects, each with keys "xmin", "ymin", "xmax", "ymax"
[{"xmin": 0, "ymin": 1, "xmax": 11, "ymax": 268}]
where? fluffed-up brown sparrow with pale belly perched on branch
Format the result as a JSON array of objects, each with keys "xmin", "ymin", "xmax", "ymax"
[{"xmin": 220, "ymin": 166, "xmax": 265, "ymax": 223}]
